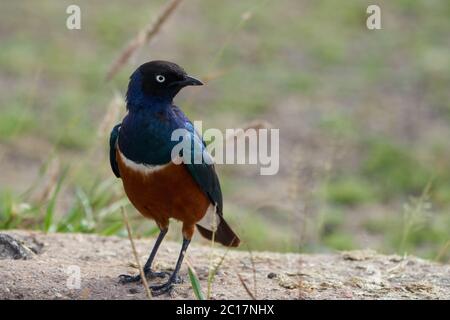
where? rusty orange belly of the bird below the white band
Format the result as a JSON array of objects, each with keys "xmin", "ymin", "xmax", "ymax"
[{"xmin": 116, "ymin": 149, "xmax": 210, "ymax": 227}]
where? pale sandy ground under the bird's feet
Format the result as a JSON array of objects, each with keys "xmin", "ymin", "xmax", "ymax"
[{"xmin": 0, "ymin": 230, "xmax": 450, "ymax": 299}]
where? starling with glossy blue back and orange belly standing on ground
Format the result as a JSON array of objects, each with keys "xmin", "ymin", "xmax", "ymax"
[{"xmin": 109, "ymin": 60, "xmax": 240, "ymax": 295}]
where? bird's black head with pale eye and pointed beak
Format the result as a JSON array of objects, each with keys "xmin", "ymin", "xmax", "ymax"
[{"xmin": 127, "ymin": 60, "xmax": 203, "ymax": 104}]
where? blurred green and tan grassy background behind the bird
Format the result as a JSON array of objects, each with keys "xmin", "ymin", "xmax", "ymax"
[{"xmin": 0, "ymin": 0, "xmax": 450, "ymax": 262}]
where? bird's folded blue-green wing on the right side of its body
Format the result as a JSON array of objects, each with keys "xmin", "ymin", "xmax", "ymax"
[{"xmin": 183, "ymin": 122, "xmax": 223, "ymax": 215}]
